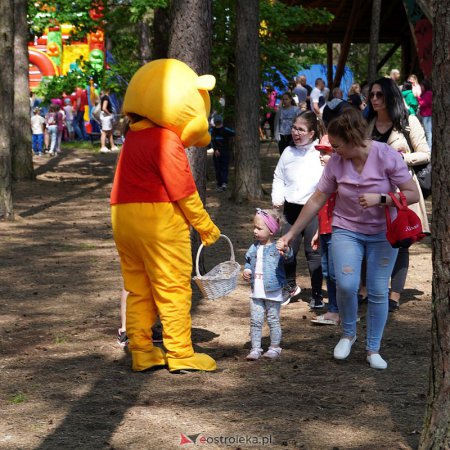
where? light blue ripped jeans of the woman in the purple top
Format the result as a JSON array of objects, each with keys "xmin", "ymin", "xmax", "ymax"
[{"xmin": 332, "ymin": 227, "xmax": 398, "ymax": 352}]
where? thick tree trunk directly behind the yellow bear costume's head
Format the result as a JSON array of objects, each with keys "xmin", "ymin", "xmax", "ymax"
[{"xmin": 168, "ymin": 0, "xmax": 212, "ymax": 202}]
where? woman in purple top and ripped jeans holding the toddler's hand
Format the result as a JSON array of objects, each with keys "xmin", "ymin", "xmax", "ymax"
[{"xmin": 277, "ymin": 108, "xmax": 419, "ymax": 369}]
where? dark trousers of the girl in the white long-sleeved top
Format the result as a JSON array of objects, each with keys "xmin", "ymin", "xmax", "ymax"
[{"xmin": 283, "ymin": 201, "xmax": 323, "ymax": 298}]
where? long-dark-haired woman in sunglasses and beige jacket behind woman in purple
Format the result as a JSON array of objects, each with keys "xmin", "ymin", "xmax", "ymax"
[{"xmin": 362, "ymin": 78, "xmax": 431, "ymax": 312}]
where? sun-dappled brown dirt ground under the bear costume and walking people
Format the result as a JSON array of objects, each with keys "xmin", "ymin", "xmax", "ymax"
[{"xmin": 0, "ymin": 145, "xmax": 431, "ymax": 450}]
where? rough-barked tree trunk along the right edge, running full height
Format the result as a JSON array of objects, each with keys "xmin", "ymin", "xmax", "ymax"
[{"xmin": 419, "ymin": 0, "xmax": 450, "ymax": 450}]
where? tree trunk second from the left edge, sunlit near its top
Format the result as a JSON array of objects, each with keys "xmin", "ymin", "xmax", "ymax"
[{"xmin": 12, "ymin": 0, "xmax": 34, "ymax": 180}]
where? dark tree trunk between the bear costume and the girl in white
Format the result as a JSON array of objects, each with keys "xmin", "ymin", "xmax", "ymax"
[{"xmin": 233, "ymin": 0, "xmax": 262, "ymax": 203}]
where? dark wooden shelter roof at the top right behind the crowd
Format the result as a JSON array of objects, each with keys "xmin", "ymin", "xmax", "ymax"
[{"xmin": 282, "ymin": 0, "xmax": 411, "ymax": 43}]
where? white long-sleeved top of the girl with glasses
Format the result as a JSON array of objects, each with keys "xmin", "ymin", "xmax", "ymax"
[{"xmin": 272, "ymin": 140, "xmax": 323, "ymax": 205}]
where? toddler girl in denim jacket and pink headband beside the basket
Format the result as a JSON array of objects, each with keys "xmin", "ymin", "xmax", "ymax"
[{"xmin": 242, "ymin": 208, "xmax": 294, "ymax": 361}]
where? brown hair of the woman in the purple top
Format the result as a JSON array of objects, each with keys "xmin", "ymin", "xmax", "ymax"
[{"xmin": 327, "ymin": 108, "xmax": 367, "ymax": 147}]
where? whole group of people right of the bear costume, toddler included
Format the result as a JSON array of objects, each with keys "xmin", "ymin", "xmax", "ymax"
[{"xmin": 243, "ymin": 70, "xmax": 432, "ymax": 369}]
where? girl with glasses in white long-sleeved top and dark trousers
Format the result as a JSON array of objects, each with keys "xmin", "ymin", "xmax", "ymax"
[{"xmin": 272, "ymin": 111, "xmax": 325, "ymax": 309}]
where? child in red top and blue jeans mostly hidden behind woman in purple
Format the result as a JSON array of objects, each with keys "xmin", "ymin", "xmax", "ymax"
[{"xmin": 311, "ymin": 135, "xmax": 339, "ymax": 325}]
